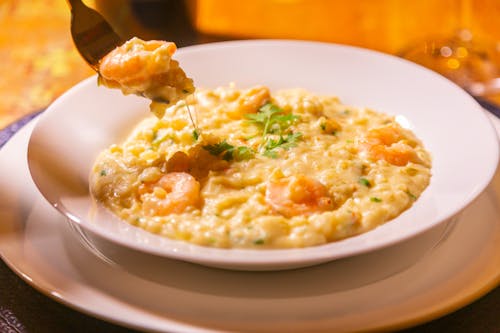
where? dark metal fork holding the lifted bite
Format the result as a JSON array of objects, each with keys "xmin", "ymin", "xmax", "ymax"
[{"xmin": 67, "ymin": 0, "xmax": 125, "ymax": 72}]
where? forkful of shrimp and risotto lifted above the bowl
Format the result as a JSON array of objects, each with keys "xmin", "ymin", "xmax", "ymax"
[{"xmin": 99, "ymin": 37, "xmax": 194, "ymax": 104}]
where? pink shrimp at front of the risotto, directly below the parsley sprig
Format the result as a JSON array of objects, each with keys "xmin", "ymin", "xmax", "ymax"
[{"xmin": 265, "ymin": 175, "xmax": 333, "ymax": 217}]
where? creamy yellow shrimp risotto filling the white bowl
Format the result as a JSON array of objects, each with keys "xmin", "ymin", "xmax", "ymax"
[{"xmin": 91, "ymin": 85, "xmax": 431, "ymax": 248}]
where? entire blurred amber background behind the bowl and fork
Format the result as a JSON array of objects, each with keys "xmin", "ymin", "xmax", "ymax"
[{"xmin": 0, "ymin": 0, "xmax": 500, "ymax": 129}]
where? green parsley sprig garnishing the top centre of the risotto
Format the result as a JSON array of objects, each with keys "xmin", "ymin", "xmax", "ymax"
[{"xmin": 246, "ymin": 103, "xmax": 302, "ymax": 158}]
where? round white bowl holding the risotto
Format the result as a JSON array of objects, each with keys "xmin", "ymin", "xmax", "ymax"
[{"xmin": 28, "ymin": 40, "xmax": 499, "ymax": 270}]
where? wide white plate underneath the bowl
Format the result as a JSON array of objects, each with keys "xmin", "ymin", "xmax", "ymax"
[{"xmin": 0, "ymin": 116, "xmax": 500, "ymax": 332}]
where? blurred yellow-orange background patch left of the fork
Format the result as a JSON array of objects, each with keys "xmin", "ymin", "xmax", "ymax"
[{"xmin": 0, "ymin": 0, "xmax": 92, "ymax": 128}]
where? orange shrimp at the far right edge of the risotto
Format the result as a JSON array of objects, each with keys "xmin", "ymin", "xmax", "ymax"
[{"xmin": 361, "ymin": 125, "xmax": 420, "ymax": 166}]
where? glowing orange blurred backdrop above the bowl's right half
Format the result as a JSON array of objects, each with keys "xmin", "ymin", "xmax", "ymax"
[{"xmin": 192, "ymin": 0, "xmax": 500, "ymax": 102}]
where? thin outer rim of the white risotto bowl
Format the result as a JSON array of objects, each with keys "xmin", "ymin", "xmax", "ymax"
[{"xmin": 28, "ymin": 39, "xmax": 499, "ymax": 270}]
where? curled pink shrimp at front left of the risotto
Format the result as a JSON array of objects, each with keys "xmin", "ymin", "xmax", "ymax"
[{"xmin": 139, "ymin": 172, "xmax": 200, "ymax": 216}]
